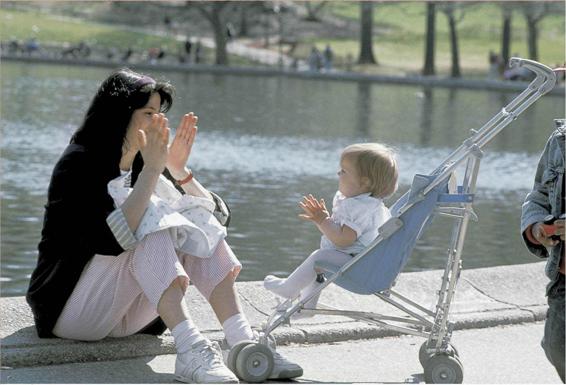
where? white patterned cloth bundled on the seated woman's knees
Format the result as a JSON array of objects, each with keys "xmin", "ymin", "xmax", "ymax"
[{"xmin": 108, "ymin": 171, "xmax": 226, "ymax": 258}]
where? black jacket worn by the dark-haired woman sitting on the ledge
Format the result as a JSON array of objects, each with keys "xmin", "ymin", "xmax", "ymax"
[{"xmin": 26, "ymin": 144, "xmax": 166, "ymax": 337}]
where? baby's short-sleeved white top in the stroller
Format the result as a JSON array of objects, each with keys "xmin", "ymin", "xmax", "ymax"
[{"xmin": 320, "ymin": 191, "xmax": 391, "ymax": 254}]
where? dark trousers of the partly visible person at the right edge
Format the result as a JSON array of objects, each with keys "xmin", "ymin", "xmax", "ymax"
[{"xmin": 541, "ymin": 274, "xmax": 564, "ymax": 383}]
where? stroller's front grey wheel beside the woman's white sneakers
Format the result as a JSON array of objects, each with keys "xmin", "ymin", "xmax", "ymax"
[{"xmin": 236, "ymin": 343, "xmax": 273, "ymax": 382}]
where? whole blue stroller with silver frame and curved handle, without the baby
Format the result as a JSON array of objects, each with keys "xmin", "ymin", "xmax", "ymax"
[{"xmin": 228, "ymin": 58, "xmax": 556, "ymax": 383}]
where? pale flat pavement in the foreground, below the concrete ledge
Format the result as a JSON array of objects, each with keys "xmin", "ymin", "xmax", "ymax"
[{"xmin": 0, "ymin": 322, "xmax": 560, "ymax": 384}]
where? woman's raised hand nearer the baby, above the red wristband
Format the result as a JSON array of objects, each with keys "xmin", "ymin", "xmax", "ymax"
[{"xmin": 167, "ymin": 112, "xmax": 198, "ymax": 179}]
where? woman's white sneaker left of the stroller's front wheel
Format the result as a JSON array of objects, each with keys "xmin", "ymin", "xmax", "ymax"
[{"xmin": 175, "ymin": 340, "xmax": 238, "ymax": 384}]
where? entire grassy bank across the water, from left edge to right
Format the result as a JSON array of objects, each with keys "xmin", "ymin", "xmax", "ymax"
[{"xmin": 0, "ymin": 1, "xmax": 565, "ymax": 77}]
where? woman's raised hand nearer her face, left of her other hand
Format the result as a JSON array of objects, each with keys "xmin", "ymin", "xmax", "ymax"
[{"xmin": 137, "ymin": 114, "xmax": 170, "ymax": 174}]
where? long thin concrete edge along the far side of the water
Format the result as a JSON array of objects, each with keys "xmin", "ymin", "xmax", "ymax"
[{"xmin": 0, "ymin": 53, "xmax": 565, "ymax": 97}]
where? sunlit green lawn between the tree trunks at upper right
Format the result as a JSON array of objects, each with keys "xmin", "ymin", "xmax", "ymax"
[{"xmin": 308, "ymin": 2, "xmax": 565, "ymax": 75}]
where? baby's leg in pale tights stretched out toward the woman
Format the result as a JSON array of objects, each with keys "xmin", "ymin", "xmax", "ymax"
[{"xmin": 263, "ymin": 249, "xmax": 352, "ymax": 298}]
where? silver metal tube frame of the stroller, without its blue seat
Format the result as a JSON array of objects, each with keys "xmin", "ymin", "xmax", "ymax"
[{"xmin": 227, "ymin": 58, "xmax": 556, "ymax": 383}]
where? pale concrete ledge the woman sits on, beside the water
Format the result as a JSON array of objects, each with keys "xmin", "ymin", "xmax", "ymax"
[{"xmin": 0, "ymin": 262, "xmax": 548, "ymax": 367}]
